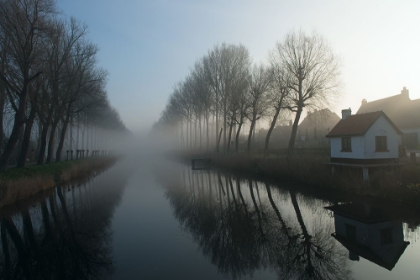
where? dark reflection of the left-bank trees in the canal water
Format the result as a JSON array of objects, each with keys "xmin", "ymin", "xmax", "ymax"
[{"xmin": 0, "ymin": 165, "xmax": 130, "ymax": 279}]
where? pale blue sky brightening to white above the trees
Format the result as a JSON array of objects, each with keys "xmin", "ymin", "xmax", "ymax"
[{"xmin": 57, "ymin": 0, "xmax": 420, "ymax": 132}]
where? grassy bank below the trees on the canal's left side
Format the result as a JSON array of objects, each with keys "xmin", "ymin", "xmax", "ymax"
[{"xmin": 0, "ymin": 157, "xmax": 116, "ymax": 207}]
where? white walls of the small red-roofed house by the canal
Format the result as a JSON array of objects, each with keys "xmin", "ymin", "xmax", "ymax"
[{"xmin": 330, "ymin": 116, "xmax": 400, "ymax": 159}]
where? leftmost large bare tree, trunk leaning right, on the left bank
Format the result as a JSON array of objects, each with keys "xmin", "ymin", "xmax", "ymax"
[{"xmin": 0, "ymin": 0, "xmax": 55, "ymax": 170}]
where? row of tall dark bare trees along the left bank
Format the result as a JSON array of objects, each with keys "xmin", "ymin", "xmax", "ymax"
[{"xmin": 0, "ymin": 0, "xmax": 126, "ymax": 170}]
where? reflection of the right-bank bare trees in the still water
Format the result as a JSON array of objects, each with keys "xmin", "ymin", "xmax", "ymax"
[{"xmin": 166, "ymin": 168, "xmax": 351, "ymax": 279}]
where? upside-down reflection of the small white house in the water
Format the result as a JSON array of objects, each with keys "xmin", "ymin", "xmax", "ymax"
[{"xmin": 327, "ymin": 204, "xmax": 410, "ymax": 270}]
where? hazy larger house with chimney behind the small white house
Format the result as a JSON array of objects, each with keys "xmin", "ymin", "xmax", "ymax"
[{"xmin": 357, "ymin": 87, "xmax": 420, "ymax": 150}]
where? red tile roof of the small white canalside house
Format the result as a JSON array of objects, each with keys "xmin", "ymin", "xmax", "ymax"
[{"xmin": 326, "ymin": 111, "xmax": 402, "ymax": 138}]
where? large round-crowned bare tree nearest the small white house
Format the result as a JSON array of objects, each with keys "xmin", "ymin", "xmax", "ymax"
[{"xmin": 275, "ymin": 31, "xmax": 339, "ymax": 154}]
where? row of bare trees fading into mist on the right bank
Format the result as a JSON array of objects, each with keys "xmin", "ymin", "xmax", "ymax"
[{"xmin": 154, "ymin": 31, "xmax": 339, "ymax": 153}]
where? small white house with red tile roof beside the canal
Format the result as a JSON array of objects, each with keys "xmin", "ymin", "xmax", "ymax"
[{"xmin": 326, "ymin": 109, "xmax": 402, "ymax": 164}]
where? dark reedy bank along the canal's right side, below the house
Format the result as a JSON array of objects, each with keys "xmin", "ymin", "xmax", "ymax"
[{"xmin": 178, "ymin": 153, "xmax": 420, "ymax": 207}]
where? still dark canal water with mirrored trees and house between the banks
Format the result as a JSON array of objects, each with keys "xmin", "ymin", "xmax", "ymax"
[{"xmin": 0, "ymin": 161, "xmax": 420, "ymax": 280}]
